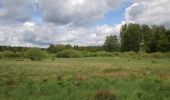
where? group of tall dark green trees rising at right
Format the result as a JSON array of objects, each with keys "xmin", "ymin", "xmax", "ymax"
[{"xmin": 104, "ymin": 23, "xmax": 170, "ymax": 53}]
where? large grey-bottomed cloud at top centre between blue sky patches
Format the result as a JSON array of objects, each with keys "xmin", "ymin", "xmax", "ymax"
[{"xmin": 39, "ymin": 0, "xmax": 121, "ymax": 26}]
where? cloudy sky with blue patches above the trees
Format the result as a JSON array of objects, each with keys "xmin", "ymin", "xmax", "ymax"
[{"xmin": 0, "ymin": 0, "xmax": 170, "ymax": 47}]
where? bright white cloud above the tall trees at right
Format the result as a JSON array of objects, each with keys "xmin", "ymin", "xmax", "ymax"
[{"xmin": 125, "ymin": 0, "xmax": 170, "ymax": 27}]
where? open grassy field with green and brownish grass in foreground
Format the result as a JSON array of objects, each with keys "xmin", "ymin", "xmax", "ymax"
[{"xmin": 0, "ymin": 57, "xmax": 170, "ymax": 100}]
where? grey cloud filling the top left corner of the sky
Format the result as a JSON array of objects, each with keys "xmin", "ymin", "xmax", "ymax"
[{"xmin": 0, "ymin": 0, "xmax": 31, "ymax": 24}]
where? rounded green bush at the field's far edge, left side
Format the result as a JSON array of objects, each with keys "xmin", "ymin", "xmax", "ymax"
[{"xmin": 27, "ymin": 48, "xmax": 46, "ymax": 61}]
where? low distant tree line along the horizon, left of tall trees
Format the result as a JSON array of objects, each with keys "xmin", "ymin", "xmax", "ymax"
[{"xmin": 0, "ymin": 44, "xmax": 104, "ymax": 53}]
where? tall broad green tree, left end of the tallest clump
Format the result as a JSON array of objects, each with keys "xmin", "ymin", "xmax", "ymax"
[{"xmin": 121, "ymin": 24, "xmax": 142, "ymax": 52}]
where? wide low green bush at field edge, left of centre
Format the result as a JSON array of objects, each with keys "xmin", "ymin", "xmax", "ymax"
[{"xmin": 56, "ymin": 50, "xmax": 81, "ymax": 58}]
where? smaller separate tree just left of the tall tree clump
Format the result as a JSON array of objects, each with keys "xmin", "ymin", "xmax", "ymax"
[{"xmin": 104, "ymin": 35, "xmax": 119, "ymax": 52}]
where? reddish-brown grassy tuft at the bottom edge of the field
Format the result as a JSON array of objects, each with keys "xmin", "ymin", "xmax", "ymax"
[{"xmin": 94, "ymin": 89, "xmax": 116, "ymax": 100}]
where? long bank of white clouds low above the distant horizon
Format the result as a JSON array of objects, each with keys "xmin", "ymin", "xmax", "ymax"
[{"xmin": 0, "ymin": 22, "xmax": 121, "ymax": 47}]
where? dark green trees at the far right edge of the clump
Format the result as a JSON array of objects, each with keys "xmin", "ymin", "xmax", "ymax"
[{"xmin": 142, "ymin": 25, "xmax": 169, "ymax": 52}]
